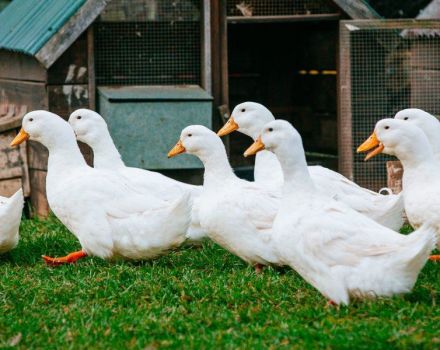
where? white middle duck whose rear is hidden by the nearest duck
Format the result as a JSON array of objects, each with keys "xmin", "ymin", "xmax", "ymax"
[{"xmin": 168, "ymin": 125, "xmax": 279, "ymax": 272}]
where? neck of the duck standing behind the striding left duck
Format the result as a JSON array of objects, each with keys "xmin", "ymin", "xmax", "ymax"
[{"xmin": 92, "ymin": 132, "xmax": 125, "ymax": 169}]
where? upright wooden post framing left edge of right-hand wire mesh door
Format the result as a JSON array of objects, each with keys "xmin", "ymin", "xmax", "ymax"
[{"xmin": 337, "ymin": 22, "xmax": 353, "ymax": 180}]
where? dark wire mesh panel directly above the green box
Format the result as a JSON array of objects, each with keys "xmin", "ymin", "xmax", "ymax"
[{"xmin": 95, "ymin": 0, "xmax": 202, "ymax": 85}]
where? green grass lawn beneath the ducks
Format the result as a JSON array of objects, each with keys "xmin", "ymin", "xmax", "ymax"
[{"xmin": 0, "ymin": 218, "xmax": 440, "ymax": 349}]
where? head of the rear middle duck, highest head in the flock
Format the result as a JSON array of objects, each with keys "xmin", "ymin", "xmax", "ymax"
[{"xmin": 217, "ymin": 102, "xmax": 275, "ymax": 140}]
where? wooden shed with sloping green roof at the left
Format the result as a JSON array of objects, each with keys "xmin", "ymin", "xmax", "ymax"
[{"xmin": 0, "ymin": 0, "xmax": 106, "ymax": 215}]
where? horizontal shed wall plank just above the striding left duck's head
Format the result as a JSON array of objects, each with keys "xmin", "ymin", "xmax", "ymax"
[{"xmin": 0, "ymin": 79, "xmax": 47, "ymax": 111}]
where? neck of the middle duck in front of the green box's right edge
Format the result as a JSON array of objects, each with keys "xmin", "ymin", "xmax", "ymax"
[{"xmin": 199, "ymin": 147, "xmax": 236, "ymax": 189}]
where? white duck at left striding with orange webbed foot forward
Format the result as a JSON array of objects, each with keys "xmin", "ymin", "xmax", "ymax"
[{"xmin": 11, "ymin": 111, "xmax": 190, "ymax": 265}]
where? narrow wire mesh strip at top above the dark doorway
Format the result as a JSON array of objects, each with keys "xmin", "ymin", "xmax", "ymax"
[{"xmin": 227, "ymin": 0, "xmax": 339, "ymax": 17}]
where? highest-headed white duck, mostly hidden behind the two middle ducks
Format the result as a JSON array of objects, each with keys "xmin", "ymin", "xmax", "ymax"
[{"xmin": 217, "ymin": 102, "xmax": 404, "ymax": 231}]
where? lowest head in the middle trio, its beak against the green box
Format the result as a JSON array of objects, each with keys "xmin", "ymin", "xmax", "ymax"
[{"xmin": 168, "ymin": 125, "xmax": 224, "ymax": 159}]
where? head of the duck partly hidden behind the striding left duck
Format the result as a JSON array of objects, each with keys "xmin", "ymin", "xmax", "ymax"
[{"xmin": 69, "ymin": 108, "xmax": 109, "ymax": 148}]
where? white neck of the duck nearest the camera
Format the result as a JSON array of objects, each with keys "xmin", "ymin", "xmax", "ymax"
[{"xmin": 277, "ymin": 147, "xmax": 314, "ymax": 194}]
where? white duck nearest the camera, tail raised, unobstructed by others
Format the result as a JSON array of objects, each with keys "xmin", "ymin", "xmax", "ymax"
[{"xmin": 245, "ymin": 120, "xmax": 436, "ymax": 304}]
